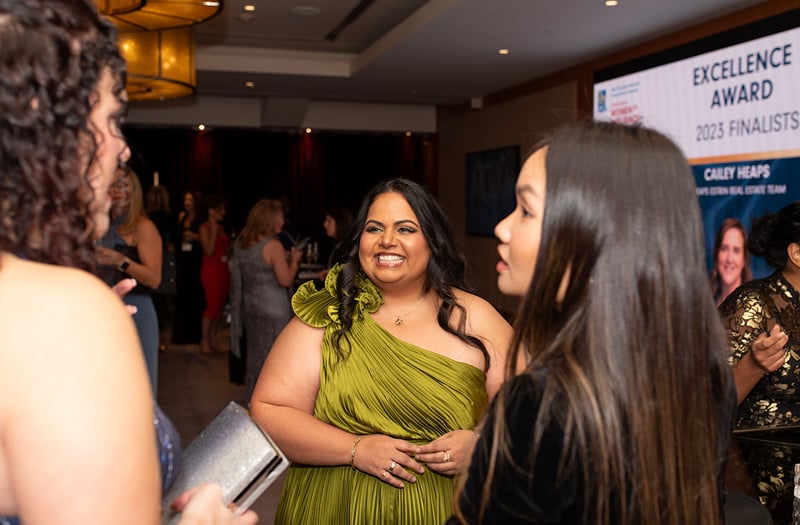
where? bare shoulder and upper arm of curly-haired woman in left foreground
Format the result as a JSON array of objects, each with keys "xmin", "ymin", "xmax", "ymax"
[{"xmin": 0, "ymin": 254, "xmax": 158, "ymax": 523}]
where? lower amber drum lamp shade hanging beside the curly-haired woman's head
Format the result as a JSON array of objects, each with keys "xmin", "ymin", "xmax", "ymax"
[{"xmin": 119, "ymin": 27, "xmax": 197, "ymax": 100}]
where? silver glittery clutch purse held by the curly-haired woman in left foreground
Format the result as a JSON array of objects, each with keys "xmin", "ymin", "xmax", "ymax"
[{"xmin": 161, "ymin": 401, "xmax": 289, "ymax": 525}]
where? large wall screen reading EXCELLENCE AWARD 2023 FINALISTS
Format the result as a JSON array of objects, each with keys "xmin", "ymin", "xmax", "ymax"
[{"xmin": 594, "ymin": 10, "xmax": 800, "ymax": 277}]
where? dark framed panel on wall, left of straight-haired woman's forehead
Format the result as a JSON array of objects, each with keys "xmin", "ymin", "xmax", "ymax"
[{"xmin": 467, "ymin": 145, "xmax": 520, "ymax": 237}]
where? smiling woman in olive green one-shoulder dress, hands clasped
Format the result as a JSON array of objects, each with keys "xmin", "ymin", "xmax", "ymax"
[{"xmin": 251, "ymin": 179, "xmax": 512, "ymax": 525}]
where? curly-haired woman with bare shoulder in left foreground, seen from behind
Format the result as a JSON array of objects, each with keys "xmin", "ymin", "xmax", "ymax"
[{"xmin": 0, "ymin": 0, "xmax": 255, "ymax": 525}]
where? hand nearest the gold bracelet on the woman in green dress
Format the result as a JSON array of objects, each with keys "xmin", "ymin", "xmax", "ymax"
[{"xmin": 353, "ymin": 434, "xmax": 425, "ymax": 489}]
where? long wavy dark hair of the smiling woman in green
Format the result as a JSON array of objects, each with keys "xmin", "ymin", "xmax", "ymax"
[{"xmin": 336, "ymin": 179, "xmax": 489, "ymax": 368}]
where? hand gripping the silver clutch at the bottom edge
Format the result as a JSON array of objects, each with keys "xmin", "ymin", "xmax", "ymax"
[{"xmin": 170, "ymin": 483, "xmax": 258, "ymax": 525}]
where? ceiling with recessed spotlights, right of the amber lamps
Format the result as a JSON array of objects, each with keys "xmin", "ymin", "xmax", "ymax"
[{"xmin": 188, "ymin": 0, "xmax": 766, "ymax": 105}]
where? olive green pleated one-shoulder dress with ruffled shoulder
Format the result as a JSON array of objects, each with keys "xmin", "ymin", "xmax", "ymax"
[{"xmin": 275, "ymin": 267, "xmax": 487, "ymax": 525}]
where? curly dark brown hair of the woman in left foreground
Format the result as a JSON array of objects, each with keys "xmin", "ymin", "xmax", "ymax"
[{"xmin": 0, "ymin": 0, "xmax": 125, "ymax": 269}]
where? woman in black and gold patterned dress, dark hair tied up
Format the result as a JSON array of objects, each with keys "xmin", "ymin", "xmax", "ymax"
[{"xmin": 719, "ymin": 202, "xmax": 800, "ymax": 524}]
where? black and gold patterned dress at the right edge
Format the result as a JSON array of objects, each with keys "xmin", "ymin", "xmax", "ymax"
[{"xmin": 719, "ymin": 271, "xmax": 800, "ymax": 509}]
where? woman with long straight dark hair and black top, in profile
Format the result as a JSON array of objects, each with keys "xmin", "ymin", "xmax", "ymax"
[{"xmin": 453, "ymin": 122, "xmax": 735, "ymax": 525}]
